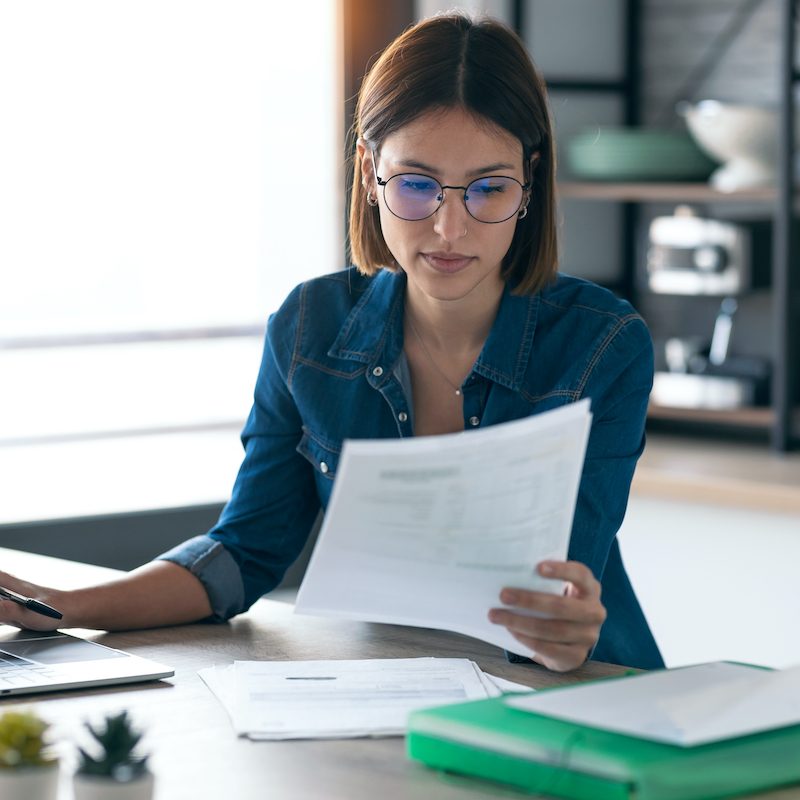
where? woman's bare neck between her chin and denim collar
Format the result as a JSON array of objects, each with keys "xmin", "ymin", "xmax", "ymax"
[{"xmin": 406, "ymin": 282, "xmax": 503, "ymax": 355}]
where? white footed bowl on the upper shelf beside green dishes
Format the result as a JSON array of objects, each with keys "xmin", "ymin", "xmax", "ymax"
[{"xmin": 678, "ymin": 100, "xmax": 778, "ymax": 192}]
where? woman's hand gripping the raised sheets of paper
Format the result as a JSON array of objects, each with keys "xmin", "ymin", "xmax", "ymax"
[{"xmin": 489, "ymin": 561, "xmax": 606, "ymax": 672}]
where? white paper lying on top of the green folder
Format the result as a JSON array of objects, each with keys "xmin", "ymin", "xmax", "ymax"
[{"xmin": 506, "ymin": 662, "xmax": 800, "ymax": 746}]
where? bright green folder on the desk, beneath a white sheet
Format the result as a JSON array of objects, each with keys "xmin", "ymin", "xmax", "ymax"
[{"xmin": 406, "ymin": 679, "xmax": 800, "ymax": 800}]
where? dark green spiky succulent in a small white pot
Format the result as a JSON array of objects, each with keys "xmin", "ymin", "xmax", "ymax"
[{"xmin": 73, "ymin": 711, "xmax": 154, "ymax": 800}]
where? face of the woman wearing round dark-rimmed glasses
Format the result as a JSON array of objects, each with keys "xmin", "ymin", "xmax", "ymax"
[{"xmin": 359, "ymin": 108, "xmax": 525, "ymax": 301}]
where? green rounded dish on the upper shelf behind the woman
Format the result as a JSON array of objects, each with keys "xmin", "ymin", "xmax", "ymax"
[{"xmin": 566, "ymin": 128, "xmax": 717, "ymax": 181}]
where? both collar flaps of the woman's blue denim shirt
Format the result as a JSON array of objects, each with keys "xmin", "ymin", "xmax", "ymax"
[{"xmin": 328, "ymin": 269, "xmax": 540, "ymax": 391}]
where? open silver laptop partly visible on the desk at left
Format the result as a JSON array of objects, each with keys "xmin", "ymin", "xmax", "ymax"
[{"xmin": 0, "ymin": 626, "xmax": 175, "ymax": 697}]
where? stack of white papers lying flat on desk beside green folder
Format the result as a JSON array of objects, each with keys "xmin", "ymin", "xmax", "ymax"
[{"xmin": 199, "ymin": 658, "xmax": 531, "ymax": 739}]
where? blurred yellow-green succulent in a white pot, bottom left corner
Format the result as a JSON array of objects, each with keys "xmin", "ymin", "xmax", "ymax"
[{"xmin": 0, "ymin": 710, "xmax": 58, "ymax": 800}]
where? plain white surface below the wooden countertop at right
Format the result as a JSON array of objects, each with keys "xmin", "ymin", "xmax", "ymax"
[{"xmin": 620, "ymin": 495, "xmax": 800, "ymax": 667}]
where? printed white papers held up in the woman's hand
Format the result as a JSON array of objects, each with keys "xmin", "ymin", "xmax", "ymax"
[{"xmin": 295, "ymin": 400, "xmax": 591, "ymax": 654}]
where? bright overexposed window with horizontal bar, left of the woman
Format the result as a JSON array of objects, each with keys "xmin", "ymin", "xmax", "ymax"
[{"xmin": 0, "ymin": 0, "xmax": 343, "ymax": 520}]
